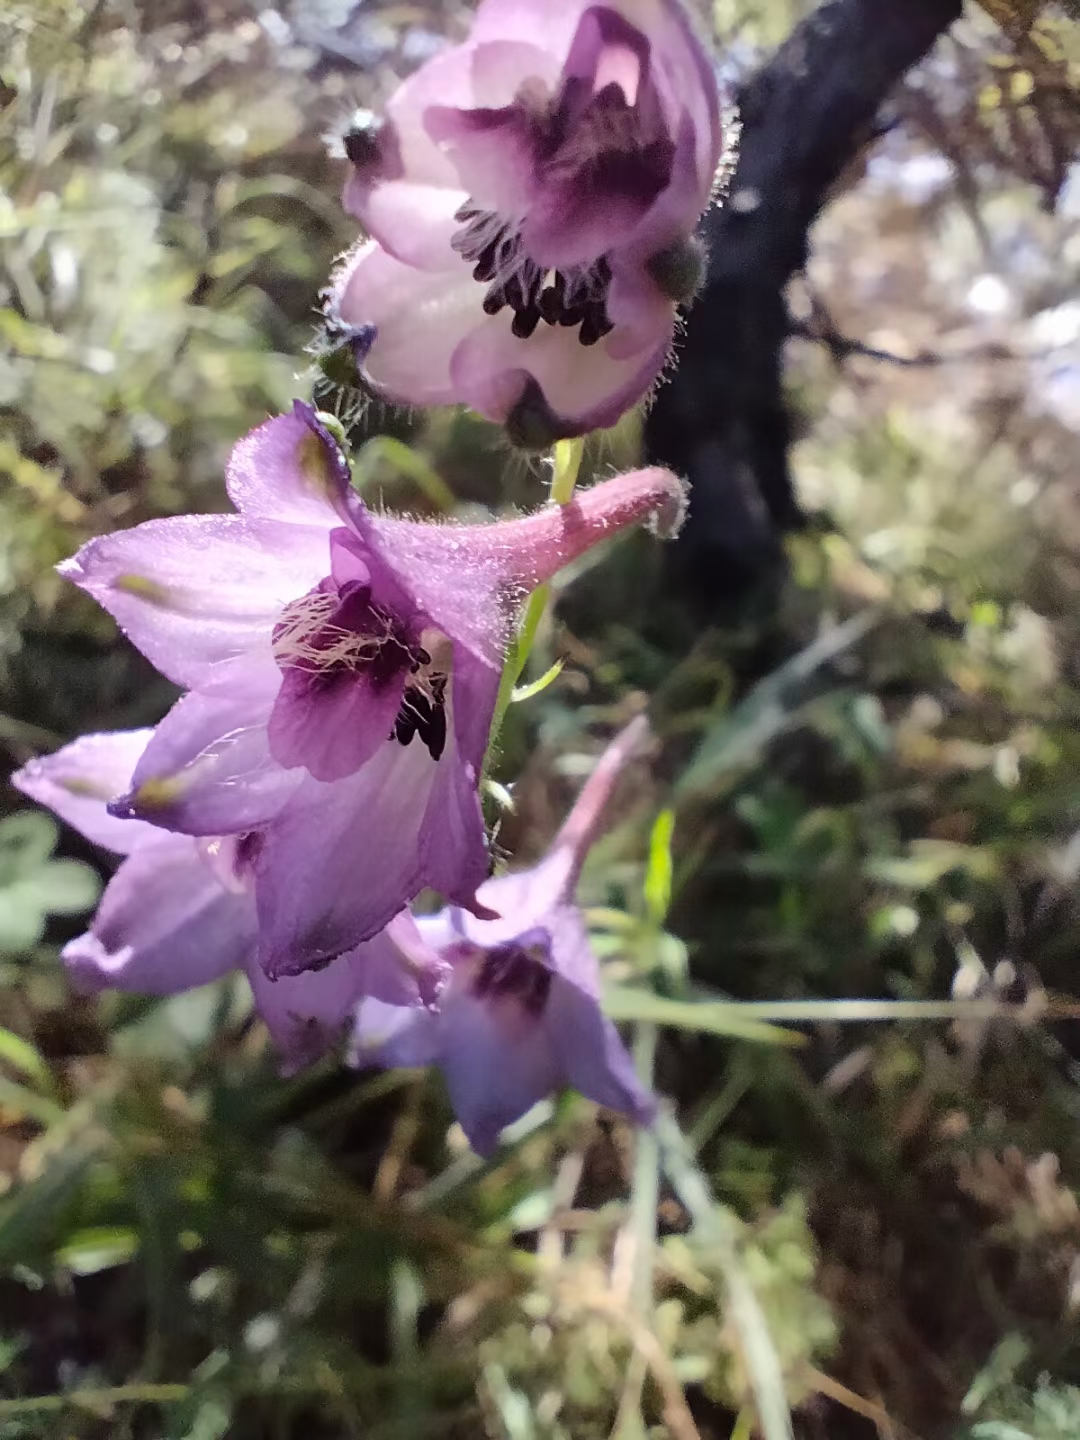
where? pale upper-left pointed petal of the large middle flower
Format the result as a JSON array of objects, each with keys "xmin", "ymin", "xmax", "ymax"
[{"xmin": 59, "ymin": 516, "xmax": 330, "ymax": 685}]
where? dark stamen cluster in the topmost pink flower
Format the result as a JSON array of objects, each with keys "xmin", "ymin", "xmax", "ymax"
[{"xmin": 451, "ymin": 203, "xmax": 612, "ymax": 346}]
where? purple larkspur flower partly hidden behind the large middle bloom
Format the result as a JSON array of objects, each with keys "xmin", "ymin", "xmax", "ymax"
[{"xmin": 12, "ymin": 730, "xmax": 442, "ymax": 1073}]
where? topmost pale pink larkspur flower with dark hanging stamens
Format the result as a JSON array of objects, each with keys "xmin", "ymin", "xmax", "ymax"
[{"xmin": 330, "ymin": 0, "xmax": 721, "ymax": 448}]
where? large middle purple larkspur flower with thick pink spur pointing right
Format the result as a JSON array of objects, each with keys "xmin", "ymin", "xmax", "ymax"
[{"xmin": 60, "ymin": 402, "xmax": 683, "ymax": 979}]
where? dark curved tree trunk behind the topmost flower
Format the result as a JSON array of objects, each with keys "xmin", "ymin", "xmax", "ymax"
[{"xmin": 645, "ymin": 0, "xmax": 960, "ymax": 608}]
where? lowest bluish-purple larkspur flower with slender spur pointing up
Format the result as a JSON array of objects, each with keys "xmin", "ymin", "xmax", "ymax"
[{"xmin": 351, "ymin": 720, "xmax": 655, "ymax": 1155}]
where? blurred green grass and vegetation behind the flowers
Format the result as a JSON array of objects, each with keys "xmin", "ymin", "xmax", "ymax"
[{"xmin": 0, "ymin": 0, "xmax": 1080, "ymax": 1440}]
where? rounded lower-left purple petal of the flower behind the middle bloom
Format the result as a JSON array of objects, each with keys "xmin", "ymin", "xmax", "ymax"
[{"xmin": 62, "ymin": 834, "xmax": 255, "ymax": 995}]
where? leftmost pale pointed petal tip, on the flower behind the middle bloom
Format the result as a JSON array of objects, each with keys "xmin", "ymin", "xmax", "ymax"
[{"xmin": 12, "ymin": 730, "xmax": 158, "ymax": 855}]
